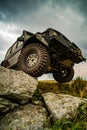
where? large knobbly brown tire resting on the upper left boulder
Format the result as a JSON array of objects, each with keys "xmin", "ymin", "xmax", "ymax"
[{"xmin": 18, "ymin": 43, "xmax": 50, "ymax": 77}]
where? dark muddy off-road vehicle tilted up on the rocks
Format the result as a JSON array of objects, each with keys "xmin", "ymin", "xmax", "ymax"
[{"xmin": 1, "ymin": 28, "xmax": 85, "ymax": 83}]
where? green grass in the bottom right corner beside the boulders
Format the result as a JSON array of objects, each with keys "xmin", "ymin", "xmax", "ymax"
[{"xmin": 51, "ymin": 103, "xmax": 87, "ymax": 130}]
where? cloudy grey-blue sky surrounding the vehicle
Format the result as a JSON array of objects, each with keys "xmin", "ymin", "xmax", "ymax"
[{"xmin": 0, "ymin": 0, "xmax": 87, "ymax": 79}]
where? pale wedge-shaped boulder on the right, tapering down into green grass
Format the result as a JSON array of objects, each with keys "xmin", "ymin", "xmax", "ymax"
[{"xmin": 42, "ymin": 92, "xmax": 87, "ymax": 120}]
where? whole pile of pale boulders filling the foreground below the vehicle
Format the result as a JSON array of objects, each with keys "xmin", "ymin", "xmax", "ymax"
[{"xmin": 0, "ymin": 66, "xmax": 87, "ymax": 130}]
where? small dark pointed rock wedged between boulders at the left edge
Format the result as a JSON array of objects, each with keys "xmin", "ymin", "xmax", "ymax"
[{"xmin": 0, "ymin": 98, "xmax": 18, "ymax": 114}]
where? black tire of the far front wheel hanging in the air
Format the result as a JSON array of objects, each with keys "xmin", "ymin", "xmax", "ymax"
[{"xmin": 53, "ymin": 68, "xmax": 74, "ymax": 83}]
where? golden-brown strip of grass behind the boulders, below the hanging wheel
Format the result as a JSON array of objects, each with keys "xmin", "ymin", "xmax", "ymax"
[{"xmin": 38, "ymin": 77, "xmax": 87, "ymax": 98}]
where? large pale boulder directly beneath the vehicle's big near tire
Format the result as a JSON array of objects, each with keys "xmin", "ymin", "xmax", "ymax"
[{"xmin": 0, "ymin": 66, "xmax": 38, "ymax": 104}]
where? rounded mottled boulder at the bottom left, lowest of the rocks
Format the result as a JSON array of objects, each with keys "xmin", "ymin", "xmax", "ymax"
[{"xmin": 0, "ymin": 104, "xmax": 49, "ymax": 130}]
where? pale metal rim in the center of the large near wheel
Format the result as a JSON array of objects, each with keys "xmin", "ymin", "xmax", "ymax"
[{"xmin": 27, "ymin": 54, "xmax": 38, "ymax": 67}]
